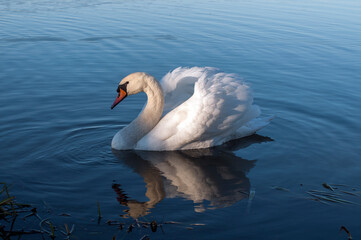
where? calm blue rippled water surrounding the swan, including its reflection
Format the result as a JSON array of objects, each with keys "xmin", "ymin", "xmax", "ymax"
[{"xmin": 0, "ymin": 0, "xmax": 361, "ymax": 240}]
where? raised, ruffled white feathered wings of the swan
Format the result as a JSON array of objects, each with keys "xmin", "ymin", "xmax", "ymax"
[{"xmin": 136, "ymin": 68, "xmax": 260, "ymax": 151}]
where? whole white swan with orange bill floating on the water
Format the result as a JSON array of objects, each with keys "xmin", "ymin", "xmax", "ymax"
[{"xmin": 111, "ymin": 67, "xmax": 272, "ymax": 151}]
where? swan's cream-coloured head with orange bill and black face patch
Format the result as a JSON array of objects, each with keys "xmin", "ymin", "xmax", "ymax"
[{"xmin": 111, "ymin": 72, "xmax": 149, "ymax": 109}]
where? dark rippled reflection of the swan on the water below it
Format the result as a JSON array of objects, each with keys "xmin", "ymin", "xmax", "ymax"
[{"xmin": 113, "ymin": 135, "xmax": 273, "ymax": 219}]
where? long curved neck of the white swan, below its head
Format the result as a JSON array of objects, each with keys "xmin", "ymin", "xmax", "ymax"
[{"xmin": 116, "ymin": 74, "xmax": 164, "ymax": 149}]
